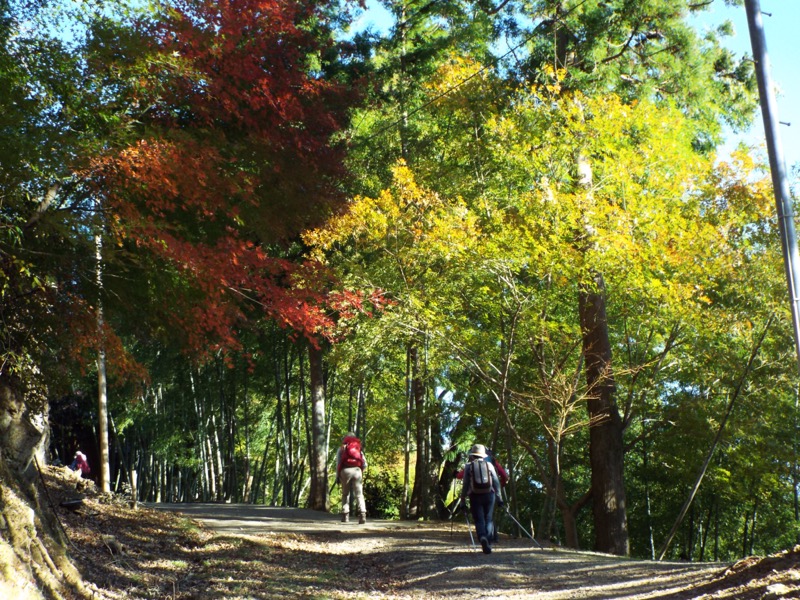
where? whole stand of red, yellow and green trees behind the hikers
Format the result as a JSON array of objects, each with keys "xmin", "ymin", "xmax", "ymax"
[{"xmin": 0, "ymin": 0, "xmax": 797, "ymax": 559}]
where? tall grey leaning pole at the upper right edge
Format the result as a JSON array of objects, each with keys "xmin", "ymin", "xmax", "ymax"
[{"xmin": 744, "ymin": 0, "xmax": 800, "ymax": 371}]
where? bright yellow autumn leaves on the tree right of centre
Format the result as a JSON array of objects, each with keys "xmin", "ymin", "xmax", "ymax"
[{"xmin": 304, "ymin": 72, "xmax": 772, "ymax": 386}]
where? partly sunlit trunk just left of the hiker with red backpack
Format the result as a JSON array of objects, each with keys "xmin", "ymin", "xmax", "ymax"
[{"xmin": 308, "ymin": 344, "xmax": 328, "ymax": 510}]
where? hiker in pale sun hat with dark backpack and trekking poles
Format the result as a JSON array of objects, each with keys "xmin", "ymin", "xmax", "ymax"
[{"xmin": 458, "ymin": 444, "xmax": 503, "ymax": 554}]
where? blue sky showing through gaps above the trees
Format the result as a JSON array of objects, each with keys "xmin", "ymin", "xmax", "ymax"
[{"xmin": 355, "ymin": 0, "xmax": 800, "ymax": 173}]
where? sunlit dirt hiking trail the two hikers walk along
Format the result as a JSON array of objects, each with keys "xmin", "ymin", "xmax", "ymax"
[{"xmin": 152, "ymin": 504, "xmax": 726, "ymax": 600}]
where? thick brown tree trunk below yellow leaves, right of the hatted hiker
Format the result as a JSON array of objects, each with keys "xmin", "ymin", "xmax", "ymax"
[{"xmin": 578, "ymin": 273, "xmax": 630, "ymax": 556}]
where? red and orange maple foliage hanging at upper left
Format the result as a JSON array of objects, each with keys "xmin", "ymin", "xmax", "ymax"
[{"xmin": 92, "ymin": 0, "xmax": 370, "ymax": 352}]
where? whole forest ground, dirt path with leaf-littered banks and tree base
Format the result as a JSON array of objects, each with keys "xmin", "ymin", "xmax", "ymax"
[{"xmin": 0, "ymin": 467, "xmax": 800, "ymax": 600}]
